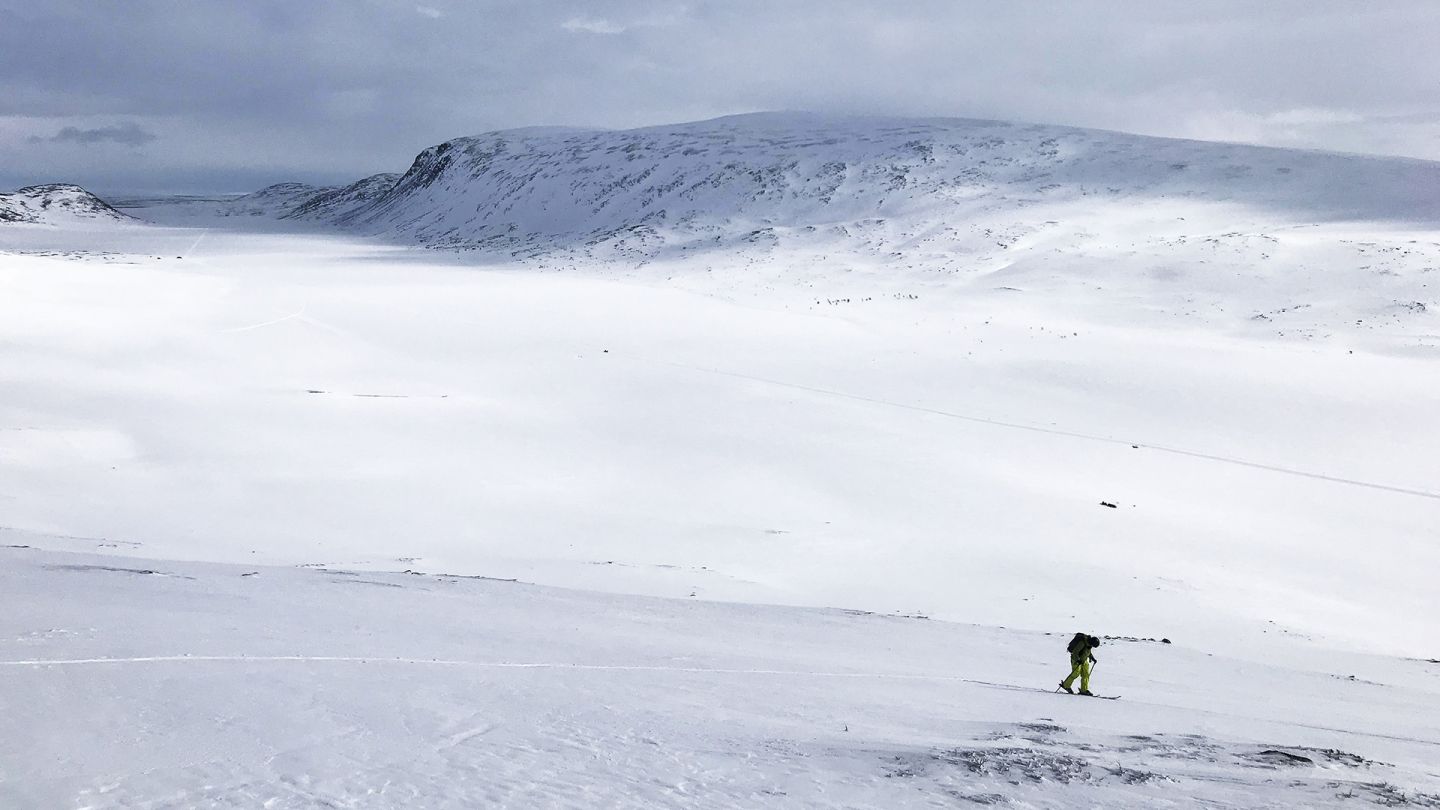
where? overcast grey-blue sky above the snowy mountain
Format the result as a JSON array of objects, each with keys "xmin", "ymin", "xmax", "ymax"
[{"xmin": 0, "ymin": 0, "xmax": 1440, "ymax": 193}]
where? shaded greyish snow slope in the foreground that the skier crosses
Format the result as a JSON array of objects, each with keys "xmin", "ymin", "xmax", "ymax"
[{"xmin": 8, "ymin": 535, "xmax": 1440, "ymax": 810}]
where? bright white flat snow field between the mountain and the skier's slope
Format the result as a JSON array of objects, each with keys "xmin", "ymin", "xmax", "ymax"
[{"xmin": 0, "ymin": 220, "xmax": 1440, "ymax": 656}]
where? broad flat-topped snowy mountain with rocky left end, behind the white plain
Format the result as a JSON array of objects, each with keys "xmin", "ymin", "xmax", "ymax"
[{"xmin": 277, "ymin": 114, "xmax": 1440, "ymax": 336}]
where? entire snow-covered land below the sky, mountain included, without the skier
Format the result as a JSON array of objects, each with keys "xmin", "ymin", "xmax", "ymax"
[{"xmin": 0, "ymin": 114, "xmax": 1440, "ymax": 809}]
